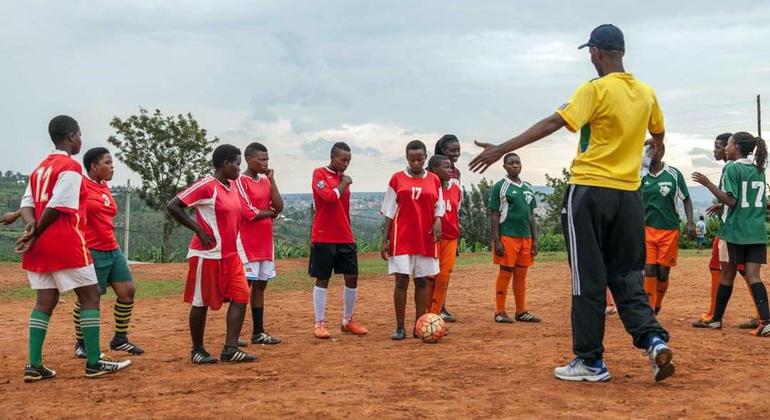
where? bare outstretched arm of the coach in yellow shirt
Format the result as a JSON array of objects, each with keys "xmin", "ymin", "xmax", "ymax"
[{"xmin": 469, "ymin": 113, "xmax": 567, "ymax": 173}]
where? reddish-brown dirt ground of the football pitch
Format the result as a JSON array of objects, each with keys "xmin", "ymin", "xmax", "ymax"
[{"xmin": 0, "ymin": 253, "xmax": 770, "ymax": 419}]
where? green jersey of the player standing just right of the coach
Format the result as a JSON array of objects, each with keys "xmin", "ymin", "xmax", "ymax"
[{"xmin": 642, "ymin": 163, "xmax": 690, "ymax": 230}]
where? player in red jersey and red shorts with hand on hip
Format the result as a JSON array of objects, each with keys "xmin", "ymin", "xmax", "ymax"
[{"xmin": 166, "ymin": 144, "xmax": 257, "ymax": 364}]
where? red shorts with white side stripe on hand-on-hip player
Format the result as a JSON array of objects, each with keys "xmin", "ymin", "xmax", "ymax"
[{"xmin": 184, "ymin": 254, "xmax": 249, "ymax": 310}]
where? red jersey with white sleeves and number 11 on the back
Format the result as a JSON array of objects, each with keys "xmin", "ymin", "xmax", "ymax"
[{"xmin": 21, "ymin": 150, "xmax": 93, "ymax": 273}]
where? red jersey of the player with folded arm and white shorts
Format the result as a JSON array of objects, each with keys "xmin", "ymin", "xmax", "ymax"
[{"xmin": 235, "ymin": 174, "xmax": 273, "ymax": 263}]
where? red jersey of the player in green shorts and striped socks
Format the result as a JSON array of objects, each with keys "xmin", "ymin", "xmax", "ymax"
[{"xmin": 83, "ymin": 176, "xmax": 120, "ymax": 251}]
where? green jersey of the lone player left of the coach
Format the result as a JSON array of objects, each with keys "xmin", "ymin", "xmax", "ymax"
[{"xmin": 489, "ymin": 177, "xmax": 537, "ymax": 238}]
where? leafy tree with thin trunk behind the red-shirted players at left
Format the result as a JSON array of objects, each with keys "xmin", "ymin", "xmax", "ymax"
[{"xmin": 107, "ymin": 107, "xmax": 219, "ymax": 261}]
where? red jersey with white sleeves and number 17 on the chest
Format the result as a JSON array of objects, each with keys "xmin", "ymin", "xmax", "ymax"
[{"xmin": 381, "ymin": 170, "xmax": 444, "ymax": 258}]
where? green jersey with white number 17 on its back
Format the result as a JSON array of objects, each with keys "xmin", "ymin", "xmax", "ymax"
[{"xmin": 722, "ymin": 158, "xmax": 767, "ymax": 245}]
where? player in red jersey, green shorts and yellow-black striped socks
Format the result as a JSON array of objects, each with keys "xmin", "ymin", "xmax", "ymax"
[{"xmin": 72, "ymin": 147, "xmax": 144, "ymax": 359}]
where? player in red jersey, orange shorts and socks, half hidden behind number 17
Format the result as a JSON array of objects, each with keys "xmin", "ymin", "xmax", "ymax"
[{"xmin": 427, "ymin": 155, "xmax": 462, "ymax": 314}]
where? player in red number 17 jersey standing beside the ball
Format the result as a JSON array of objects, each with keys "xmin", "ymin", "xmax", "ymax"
[{"xmin": 381, "ymin": 140, "xmax": 444, "ymax": 340}]
